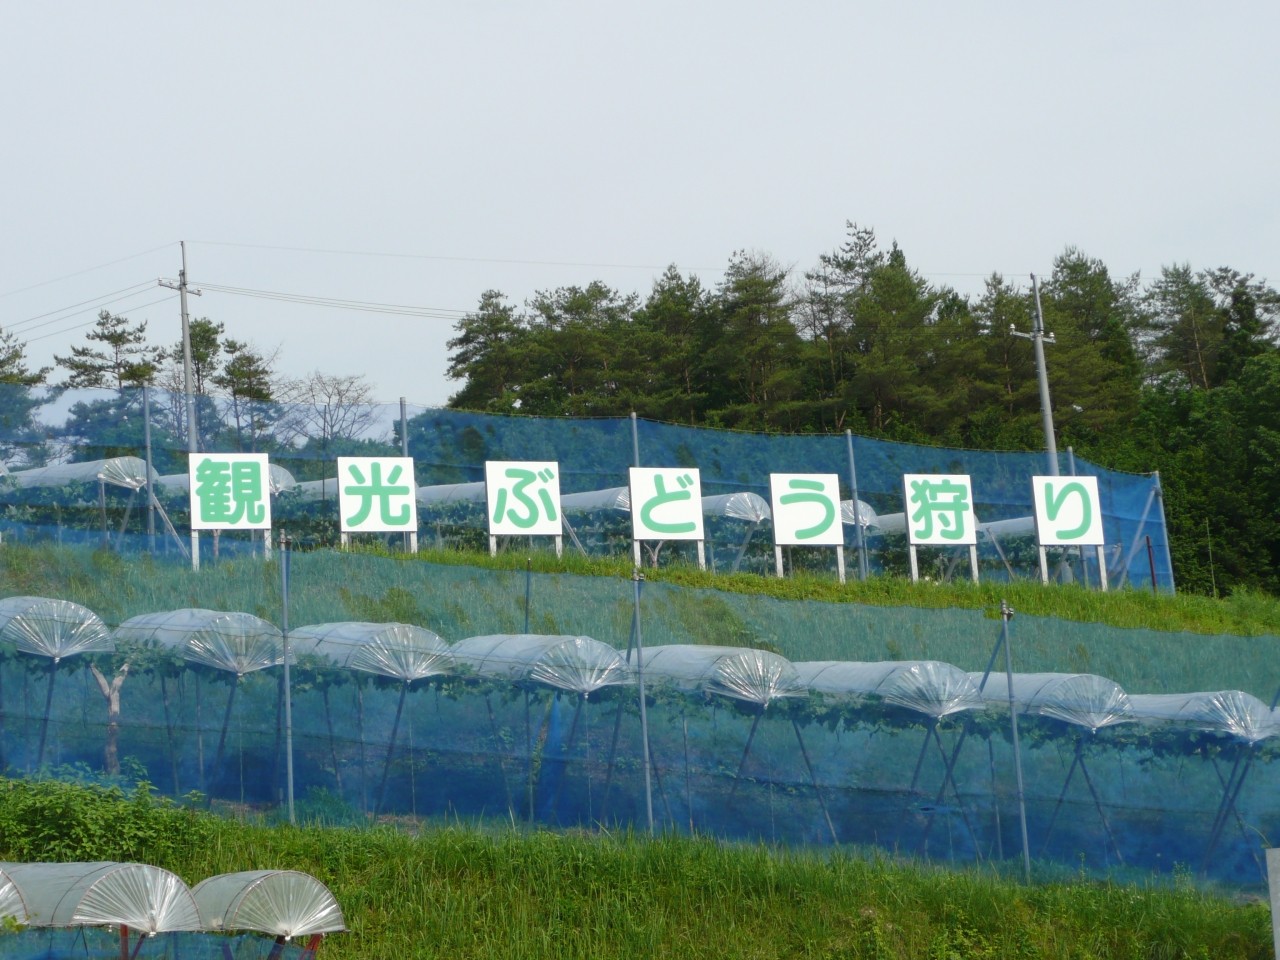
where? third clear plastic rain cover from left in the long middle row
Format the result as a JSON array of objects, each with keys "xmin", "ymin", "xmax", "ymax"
[{"xmin": 289, "ymin": 621, "xmax": 454, "ymax": 684}]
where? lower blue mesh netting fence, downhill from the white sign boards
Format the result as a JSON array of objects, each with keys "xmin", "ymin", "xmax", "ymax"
[{"xmin": 0, "ymin": 549, "xmax": 1280, "ymax": 886}]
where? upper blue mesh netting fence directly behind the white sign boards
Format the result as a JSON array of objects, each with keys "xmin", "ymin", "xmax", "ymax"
[{"xmin": 0, "ymin": 385, "xmax": 1174, "ymax": 590}]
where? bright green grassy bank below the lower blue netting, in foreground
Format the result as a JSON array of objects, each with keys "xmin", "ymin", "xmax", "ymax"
[{"xmin": 0, "ymin": 780, "xmax": 1271, "ymax": 960}]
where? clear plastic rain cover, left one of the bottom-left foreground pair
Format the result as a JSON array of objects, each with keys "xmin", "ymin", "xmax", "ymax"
[{"xmin": 0, "ymin": 861, "xmax": 204, "ymax": 934}]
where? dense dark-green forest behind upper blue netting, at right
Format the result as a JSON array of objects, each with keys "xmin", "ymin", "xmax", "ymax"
[{"xmin": 449, "ymin": 223, "xmax": 1280, "ymax": 594}]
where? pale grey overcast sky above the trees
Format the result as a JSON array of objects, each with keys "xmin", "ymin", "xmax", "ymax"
[{"xmin": 0, "ymin": 0, "xmax": 1280, "ymax": 406}]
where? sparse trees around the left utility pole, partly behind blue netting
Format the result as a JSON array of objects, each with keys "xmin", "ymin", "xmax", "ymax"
[{"xmin": 0, "ymin": 310, "xmax": 375, "ymax": 479}]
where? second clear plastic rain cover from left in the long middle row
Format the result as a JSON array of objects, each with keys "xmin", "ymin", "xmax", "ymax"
[{"xmin": 114, "ymin": 608, "xmax": 284, "ymax": 677}]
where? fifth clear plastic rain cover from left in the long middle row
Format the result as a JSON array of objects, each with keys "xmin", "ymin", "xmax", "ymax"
[{"xmin": 643, "ymin": 644, "xmax": 809, "ymax": 707}]
